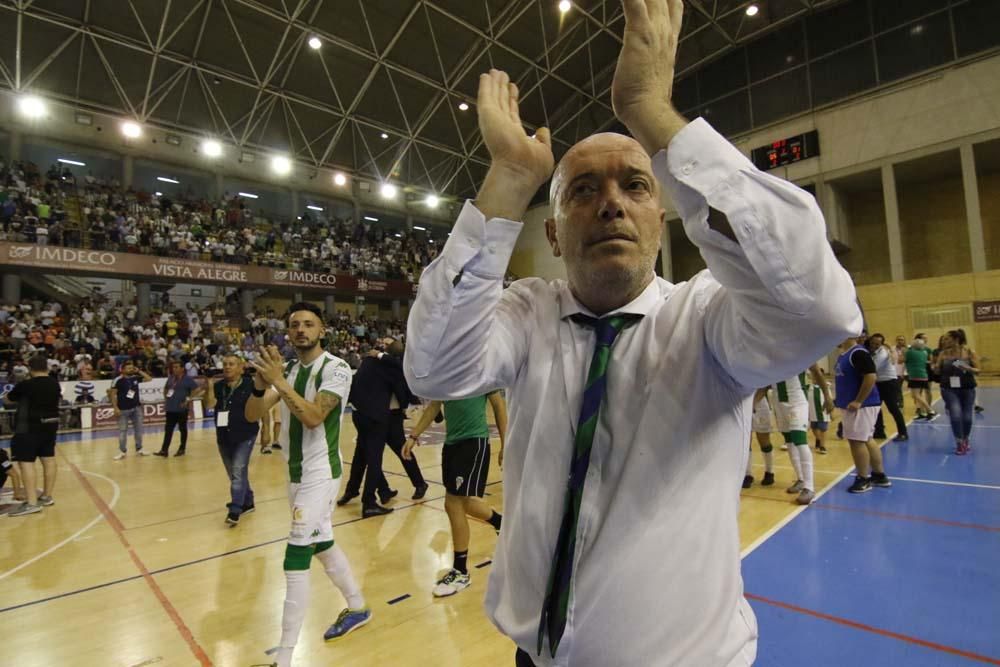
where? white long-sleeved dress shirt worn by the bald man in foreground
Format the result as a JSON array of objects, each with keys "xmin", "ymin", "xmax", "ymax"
[{"xmin": 404, "ymin": 120, "xmax": 862, "ymax": 667}]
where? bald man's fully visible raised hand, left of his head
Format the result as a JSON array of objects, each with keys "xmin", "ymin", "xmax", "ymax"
[{"xmin": 476, "ymin": 70, "xmax": 555, "ymax": 220}]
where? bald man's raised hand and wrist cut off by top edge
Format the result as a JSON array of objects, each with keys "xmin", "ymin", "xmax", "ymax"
[{"xmin": 611, "ymin": 0, "xmax": 685, "ymax": 155}]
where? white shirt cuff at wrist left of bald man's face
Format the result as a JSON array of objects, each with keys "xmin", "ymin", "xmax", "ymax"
[{"xmin": 442, "ymin": 200, "xmax": 524, "ymax": 278}]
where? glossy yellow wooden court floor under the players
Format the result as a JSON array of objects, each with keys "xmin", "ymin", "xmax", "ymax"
[{"xmin": 0, "ymin": 396, "xmax": 912, "ymax": 667}]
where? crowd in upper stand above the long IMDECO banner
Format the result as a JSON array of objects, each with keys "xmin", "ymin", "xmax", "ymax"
[{"xmin": 0, "ymin": 159, "xmax": 446, "ymax": 282}]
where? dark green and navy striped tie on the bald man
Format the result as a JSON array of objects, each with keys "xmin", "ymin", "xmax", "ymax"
[{"xmin": 538, "ymin": 314, "xmax": 642, "ymax": 657}]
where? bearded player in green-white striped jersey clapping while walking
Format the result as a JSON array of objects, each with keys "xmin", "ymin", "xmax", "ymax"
[{"xmin": 246, "ymin": 303, "xmax": 372, "ymax": 667}]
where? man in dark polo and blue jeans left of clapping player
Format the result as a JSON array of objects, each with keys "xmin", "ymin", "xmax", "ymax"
[{"xmin": 205, "ymin": 354, "xmax": 260, "ymax": 526}]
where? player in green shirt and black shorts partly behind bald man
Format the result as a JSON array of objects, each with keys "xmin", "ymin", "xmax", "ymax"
[{"xmin": 403, "ymin": 391, "xmax": 507, "ymax": 598}]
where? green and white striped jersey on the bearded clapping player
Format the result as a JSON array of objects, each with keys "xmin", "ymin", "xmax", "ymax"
[{"xmin": 280, "ymin": 352, "xmax": 353, "ymax": 483}]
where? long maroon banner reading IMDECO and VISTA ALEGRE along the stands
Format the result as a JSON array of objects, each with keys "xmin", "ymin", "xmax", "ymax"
[{"xmin": 0, "ymin": 241, "xmax": 417, "ymax": 299}]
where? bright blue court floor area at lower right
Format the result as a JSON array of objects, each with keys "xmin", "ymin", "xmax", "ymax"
[{"xmin": 743, "ymin": 388, "xmax": 1000, "ymax": 667}]
